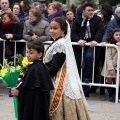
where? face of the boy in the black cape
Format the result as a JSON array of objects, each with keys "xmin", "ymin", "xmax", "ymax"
[{"xmin": 26, "ymin": 48, "xmax": 42, "ymax": 62}]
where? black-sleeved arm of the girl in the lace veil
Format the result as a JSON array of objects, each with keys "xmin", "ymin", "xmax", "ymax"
[{"xmin": 46, "ymin": 53, "xmax": 66, "ymax": 77}]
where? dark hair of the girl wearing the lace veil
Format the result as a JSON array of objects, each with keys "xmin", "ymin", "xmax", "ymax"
[{"xmin": 52, "ymin": 17, "xmax": 67, "ymax": 35}]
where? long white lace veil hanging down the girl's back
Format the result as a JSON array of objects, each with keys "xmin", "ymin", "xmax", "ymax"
[{"xmin": 64, "ymin": 21, "xmax": 83, "ymax": 99}]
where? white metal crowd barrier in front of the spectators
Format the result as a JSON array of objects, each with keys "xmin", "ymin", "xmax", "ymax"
[{"xmin": 0, "ymin": 39, "xmax": 120, "ymax": 103}]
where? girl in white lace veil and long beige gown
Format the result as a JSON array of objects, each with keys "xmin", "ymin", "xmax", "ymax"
[{"xmin": 44, "ymin": 17, "xmax": 90, "ymax": 120}]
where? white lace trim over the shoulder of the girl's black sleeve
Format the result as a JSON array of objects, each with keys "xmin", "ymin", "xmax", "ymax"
[{"xmin": 44, "ymin": 43, "xmax": 66, "ymax": 63}]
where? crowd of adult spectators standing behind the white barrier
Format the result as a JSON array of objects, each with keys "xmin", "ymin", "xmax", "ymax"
[{"xmin": 0, "ymin": 0, "xmax": 120, "ymax": 101}]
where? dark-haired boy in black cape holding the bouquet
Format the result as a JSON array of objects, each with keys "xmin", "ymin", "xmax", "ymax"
[{"xmin": 11, "ymin": 40, "xmax": 53, "ymax": 120}]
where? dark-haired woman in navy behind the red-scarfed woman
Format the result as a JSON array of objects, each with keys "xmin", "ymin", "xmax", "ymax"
[{"xmin": 12, "ymin": 3, "xmax": 24, "ymax": 25}]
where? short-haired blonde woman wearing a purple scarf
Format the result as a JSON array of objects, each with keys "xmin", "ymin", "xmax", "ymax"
[{"xmin": 48, "ymin": 1, "xmax": 63, "ymax": 23}]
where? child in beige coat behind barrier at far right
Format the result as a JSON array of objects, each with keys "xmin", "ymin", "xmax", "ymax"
[{"xmin": 101, "ymin": 28, "xmax": 120, "ymax": 102}]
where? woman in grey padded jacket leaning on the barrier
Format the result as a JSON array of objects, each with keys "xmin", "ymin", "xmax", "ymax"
[{"xmin": 23, "ymin": 8, "xmax": 51, "ymax": 42}]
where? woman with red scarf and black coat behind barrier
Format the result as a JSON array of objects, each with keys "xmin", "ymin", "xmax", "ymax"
[{"xmin": 0, "ymin": 11, "xmax": 24, "ymax": 62}]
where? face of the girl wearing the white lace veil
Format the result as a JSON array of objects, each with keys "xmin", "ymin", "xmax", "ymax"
[{"xmin": 50, "ymin": 21, "xmax": 64, "ymax": 40}]
